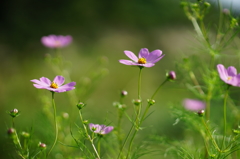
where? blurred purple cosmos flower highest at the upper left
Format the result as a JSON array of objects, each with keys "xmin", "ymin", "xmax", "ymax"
[{"xmin": 41, "ymin": 35, "xmax": 72, "ymax": 48}]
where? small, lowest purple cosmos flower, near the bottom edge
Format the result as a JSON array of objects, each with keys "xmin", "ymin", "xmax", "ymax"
[{"xmin": 89, "ymin": 123, "xmax": 113, "ymax": 135}]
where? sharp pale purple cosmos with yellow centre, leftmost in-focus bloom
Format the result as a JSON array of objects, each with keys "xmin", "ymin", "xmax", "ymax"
[{"xmin": 31, "ymin": 76, "xmax": 76, "ymax": 93}]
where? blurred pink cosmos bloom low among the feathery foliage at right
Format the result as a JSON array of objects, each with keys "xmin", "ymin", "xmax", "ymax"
[{"xmin": 183, "ymin": 99, "xmax": 206, "ymax": 112}]
